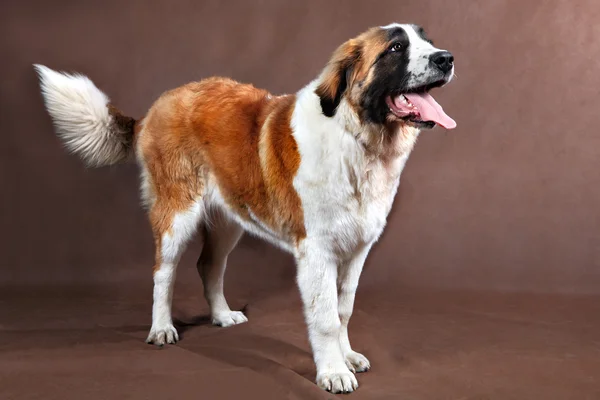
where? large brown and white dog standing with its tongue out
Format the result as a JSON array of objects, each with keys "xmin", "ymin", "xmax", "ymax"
[{"xmin": 34, "ymin": 23, "xmax": 456, "ymax": 393}]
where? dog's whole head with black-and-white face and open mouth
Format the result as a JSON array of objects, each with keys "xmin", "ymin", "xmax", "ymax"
[{"xmin": 315, "ymin": 24, "xmax": 456, "ymax": 129}]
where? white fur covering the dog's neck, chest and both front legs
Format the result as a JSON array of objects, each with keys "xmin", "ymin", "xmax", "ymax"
[{"xmin": 292, "ymin": 82, "xmax": 418, "ymax": 392}]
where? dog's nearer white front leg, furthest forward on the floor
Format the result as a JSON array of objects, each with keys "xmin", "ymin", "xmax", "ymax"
[{"xmin": 297, "ymin": 242, "xmax": 358, "ymax": 393}]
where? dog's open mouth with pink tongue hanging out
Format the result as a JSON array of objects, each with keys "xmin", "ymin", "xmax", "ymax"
[{"xmin": 385, "ymin": 85, "xmax": 456, "ymax": 129}]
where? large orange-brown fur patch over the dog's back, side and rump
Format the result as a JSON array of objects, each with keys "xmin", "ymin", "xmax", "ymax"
[{"xmin": 139, "ymin": 78, "xmax": 306, "ymax": 274}]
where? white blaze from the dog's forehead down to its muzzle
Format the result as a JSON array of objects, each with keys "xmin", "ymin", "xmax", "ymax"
[{"xmin": 381, "ymin": 24, "xmax": 441, "ymax": 85}]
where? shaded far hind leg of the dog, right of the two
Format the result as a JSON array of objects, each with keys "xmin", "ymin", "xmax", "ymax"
[{"xmin": 196, "ymin": 211, "xmax": 248, "ymax": 327}]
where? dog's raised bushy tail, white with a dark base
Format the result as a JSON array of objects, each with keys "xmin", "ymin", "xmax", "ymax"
[{"xmin": 34, "ymin": 64, "xmax": 136, "ymax": 167}]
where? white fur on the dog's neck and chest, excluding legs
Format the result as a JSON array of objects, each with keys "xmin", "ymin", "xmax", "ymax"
[{"xmin": 292, "ymin": 85, "xmax": 417, "ymax": 256}]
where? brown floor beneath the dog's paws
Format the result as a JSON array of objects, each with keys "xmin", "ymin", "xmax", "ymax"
[{"xmin": 0, "ymin": 279, "xmax": 600, "ymax": 400}]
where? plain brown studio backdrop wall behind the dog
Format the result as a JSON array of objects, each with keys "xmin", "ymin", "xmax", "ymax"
[{"xmin": 0, "ymin": 0, "xmax": 600, "ymax": 399}]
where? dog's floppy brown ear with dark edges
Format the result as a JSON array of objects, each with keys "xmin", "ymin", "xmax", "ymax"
[{"xmin": 315, "ymin": 40, "xmax": 361, "ymax": 117}]
